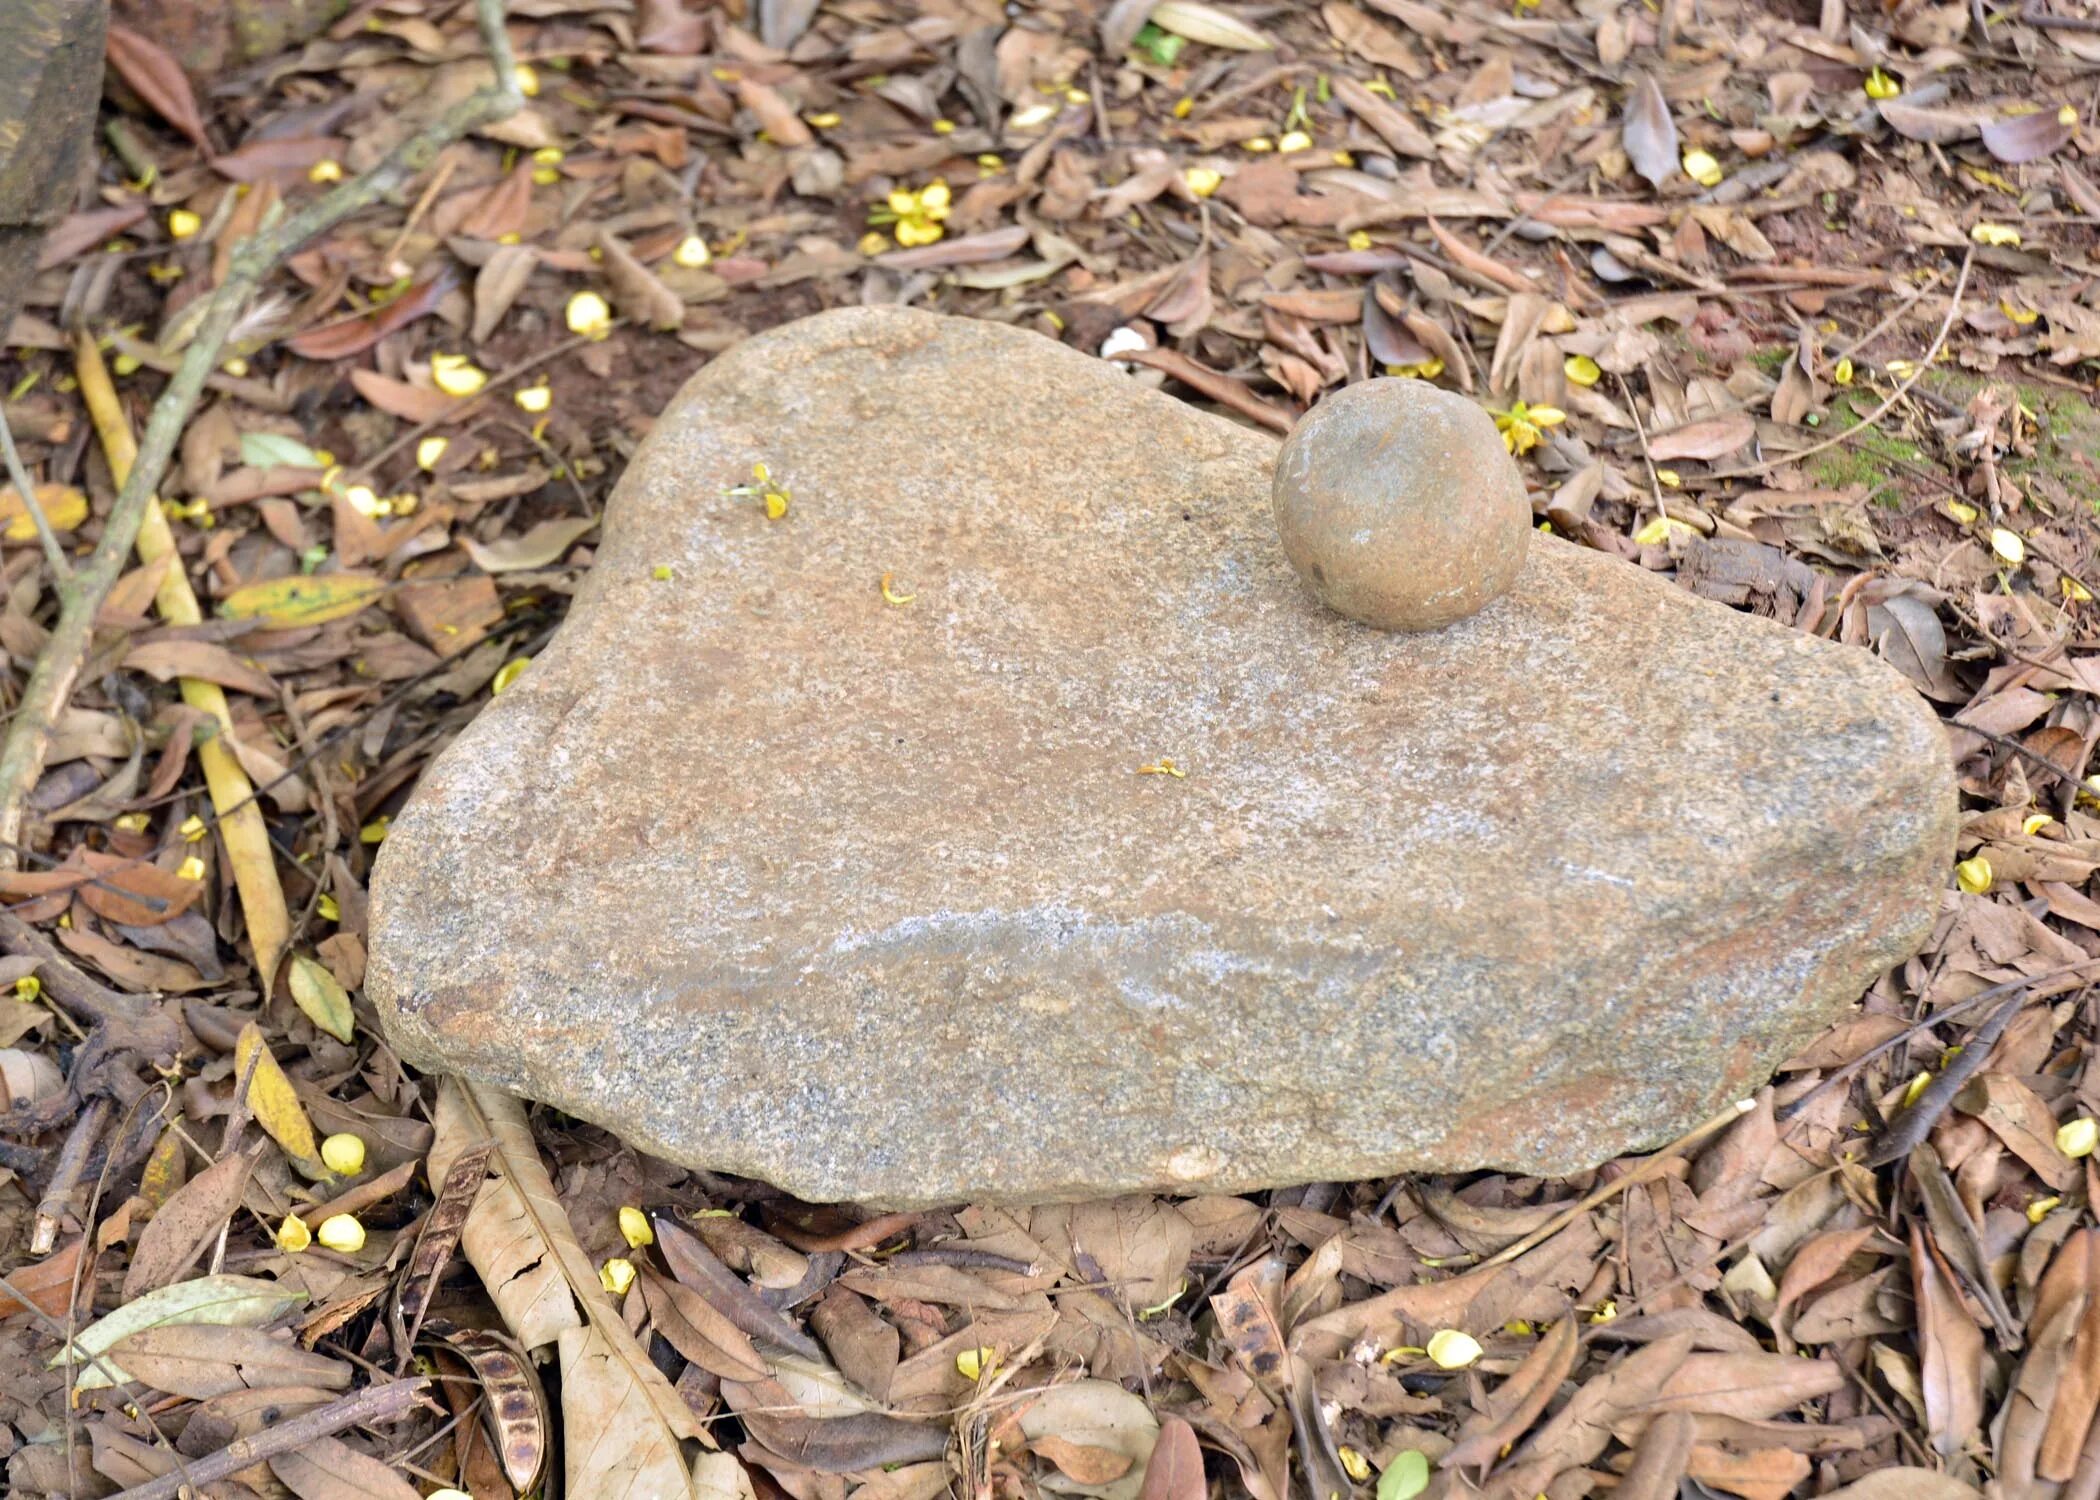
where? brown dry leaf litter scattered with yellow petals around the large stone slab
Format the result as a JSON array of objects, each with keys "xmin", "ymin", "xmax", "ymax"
[{"xmin": 0, "ymin": 0, "xmax": 2100, "ymax": 1500}]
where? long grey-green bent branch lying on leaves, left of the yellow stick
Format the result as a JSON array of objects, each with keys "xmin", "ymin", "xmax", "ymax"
[{"xmin": 0, "ymin": 0, "xmax": 525, "ymax": 870}]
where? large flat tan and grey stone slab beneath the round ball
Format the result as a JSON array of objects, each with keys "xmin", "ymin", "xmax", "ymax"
[{"xmin": 370, "ymin": 309, "xmax": 1955, "ymax": 1206}]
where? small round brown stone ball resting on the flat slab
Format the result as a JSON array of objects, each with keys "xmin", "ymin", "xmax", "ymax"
[{"xmin": 1271, "ymin": 380, "xmax": 1531, "ymax": 630}]
